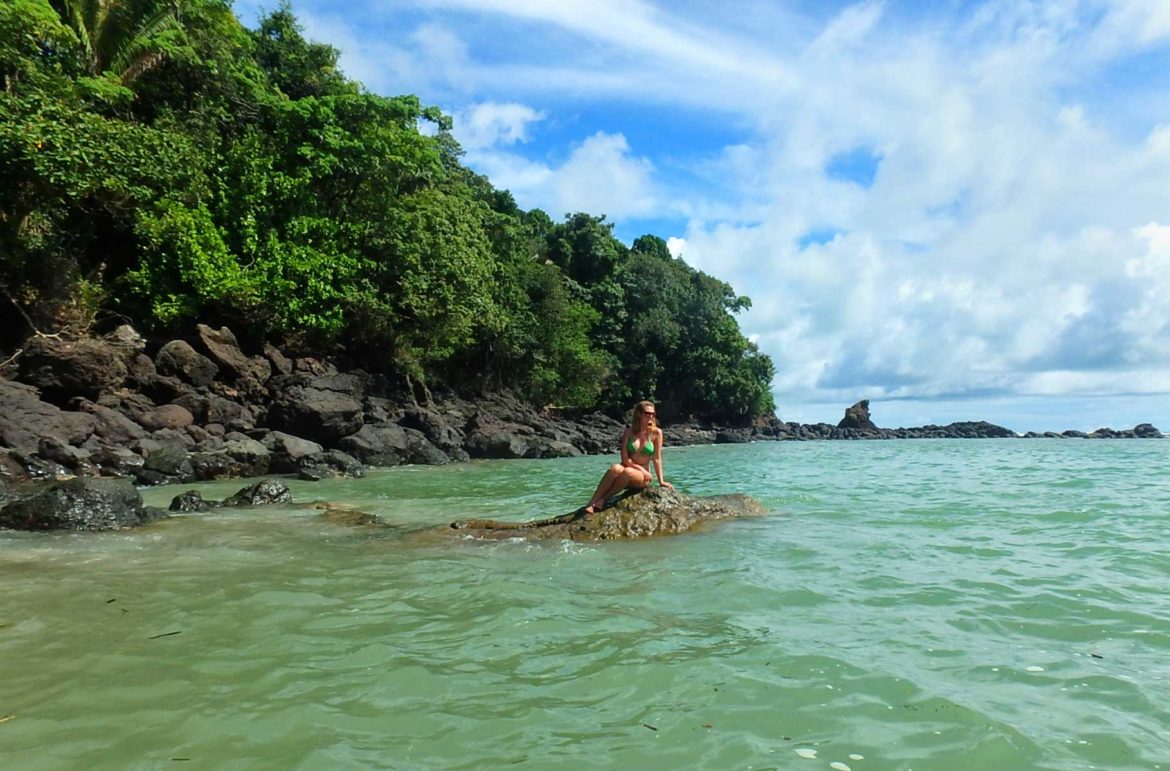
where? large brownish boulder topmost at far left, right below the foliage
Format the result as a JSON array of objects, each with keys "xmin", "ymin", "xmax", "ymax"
[{"xmin": 19, "ymin": 337, "xmax": 126, "ymax": 406}]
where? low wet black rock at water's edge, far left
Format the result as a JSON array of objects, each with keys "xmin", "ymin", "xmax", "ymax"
[{"xmin": 0, "ymin": 479, "xmax": 160, "ymax": 530}]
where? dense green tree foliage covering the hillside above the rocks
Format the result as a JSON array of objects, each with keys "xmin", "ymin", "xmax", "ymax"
[{"xmin": 0, "ymin": 0, "xmax": 772, "ymax": 420}]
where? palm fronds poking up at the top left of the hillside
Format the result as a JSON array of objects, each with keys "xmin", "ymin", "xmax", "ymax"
[{"xmin": 49, "ymin": 0, "xmax": 183, "ymax": 85}]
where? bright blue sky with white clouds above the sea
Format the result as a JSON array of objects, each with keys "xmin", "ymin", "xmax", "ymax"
[{"xmin": 236, "ymin": 0, "xmax": 1170, "ymax": 431}]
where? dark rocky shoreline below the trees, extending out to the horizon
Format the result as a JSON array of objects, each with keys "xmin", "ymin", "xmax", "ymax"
[{"xmin": 0, "ymin": 325, "xmax": 1162, "ymax": 531}]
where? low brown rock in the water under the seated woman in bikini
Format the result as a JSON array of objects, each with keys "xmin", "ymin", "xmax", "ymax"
[{"xmin": 445, "ymin": 488, "xmax": 765, "ymax": 541}]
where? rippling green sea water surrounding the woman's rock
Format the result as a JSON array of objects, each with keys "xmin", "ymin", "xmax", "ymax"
[{"xmin": 0, "ymin": 440, "xmax": 1170, "ymax": 771}]
